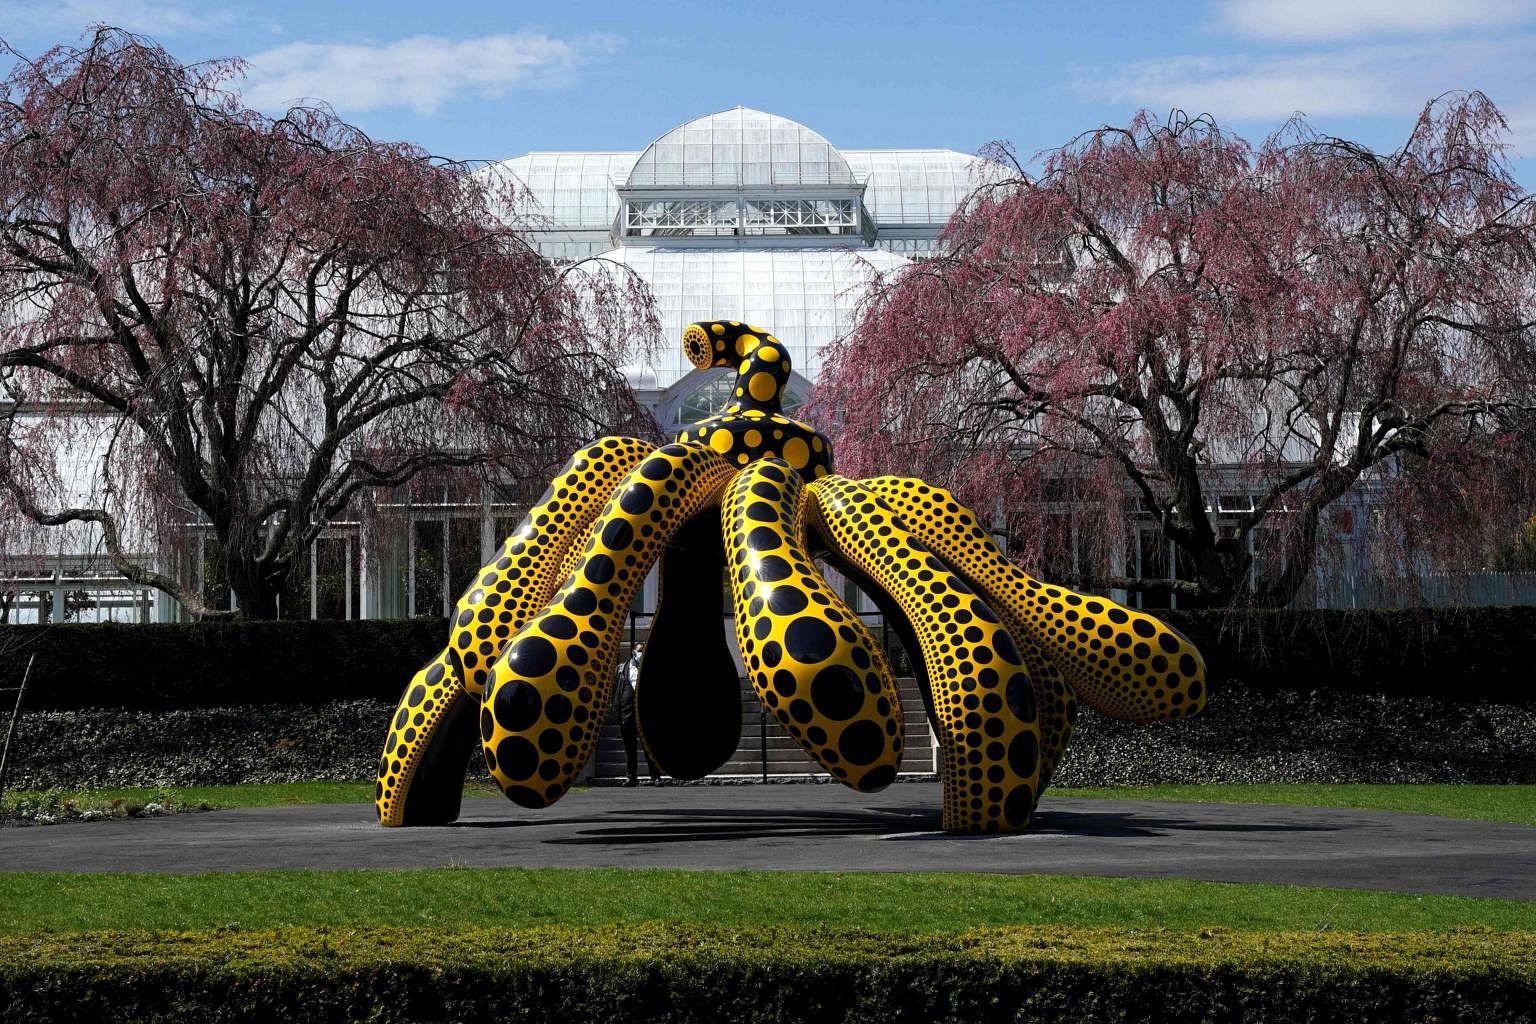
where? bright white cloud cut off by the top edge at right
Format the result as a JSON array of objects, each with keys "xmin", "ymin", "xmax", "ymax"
[{"xmin": 1218, "ymin": 0, "xmax": 1536, "ymax": 43}]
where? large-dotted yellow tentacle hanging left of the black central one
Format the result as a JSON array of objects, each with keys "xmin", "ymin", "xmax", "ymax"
[{"xmin": 479, "ymin": 444, "xmax": 734, "ymax": 808}]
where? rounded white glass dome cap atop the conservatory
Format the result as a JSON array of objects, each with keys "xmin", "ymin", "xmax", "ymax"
[{"xmin": 625, "ymin": 106, "xmax": 857, "ymax": 189}]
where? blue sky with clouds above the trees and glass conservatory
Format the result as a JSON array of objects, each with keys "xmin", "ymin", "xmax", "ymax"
[{"xmin": 9, "ymin": 0, "xmax": 1536, "ymax": 186}]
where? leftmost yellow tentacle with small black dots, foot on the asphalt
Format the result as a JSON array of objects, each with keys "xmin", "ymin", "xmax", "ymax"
[{"xmin": 373, "ymin": 438, "xmax": 651, "ymax": 826}]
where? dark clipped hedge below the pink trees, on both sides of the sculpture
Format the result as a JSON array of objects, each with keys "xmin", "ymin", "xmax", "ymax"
[{"xmin": 0, "ymin": 608, "xmax": 1536, "ymax": 709}]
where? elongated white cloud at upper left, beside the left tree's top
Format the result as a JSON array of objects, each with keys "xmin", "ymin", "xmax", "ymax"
[{"xmin": 243, "ymin": 32, "xmax": 621, "ymax": 114}]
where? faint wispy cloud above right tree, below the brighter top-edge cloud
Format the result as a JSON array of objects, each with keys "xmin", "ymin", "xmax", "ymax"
[{"xmin": 1071, "ymin": 35, "xmax": 1536, "ymax": 123}]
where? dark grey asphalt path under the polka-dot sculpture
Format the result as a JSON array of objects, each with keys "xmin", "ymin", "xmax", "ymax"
[{"xmin": 0, "ymin": 783, "xmax": 1536, "ymax": 900}]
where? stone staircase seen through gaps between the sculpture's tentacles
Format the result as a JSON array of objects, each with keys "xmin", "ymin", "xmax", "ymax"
[{"xmin": 587, "ymin": 677, "xmax": 937, "ymax": 786}]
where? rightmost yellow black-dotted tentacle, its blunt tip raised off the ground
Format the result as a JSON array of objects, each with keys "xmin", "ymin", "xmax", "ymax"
[{"xmin": 869, "ymin": 476, "xmax": 1206, "ymax": 722}]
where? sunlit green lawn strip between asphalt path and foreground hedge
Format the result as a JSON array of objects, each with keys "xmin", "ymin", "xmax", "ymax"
[{"xmin": 0, "ymin": 867, "xmax": 1536, "ymax": 933}]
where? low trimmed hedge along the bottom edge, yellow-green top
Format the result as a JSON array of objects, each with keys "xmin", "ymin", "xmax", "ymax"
[{"xmin": 0, "ymin": 924, "xmax": 1536, "ymax": 1024}]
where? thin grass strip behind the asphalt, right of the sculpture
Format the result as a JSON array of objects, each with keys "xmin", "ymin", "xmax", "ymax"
[{"xmin": 1044, "ymin": 783, "xmax": 1536, "ymax": 824}]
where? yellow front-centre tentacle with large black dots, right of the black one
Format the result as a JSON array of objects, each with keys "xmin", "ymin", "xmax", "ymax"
[{"xmin": 720, "ymin": 459, "xmax": 902, "ymax": 792}]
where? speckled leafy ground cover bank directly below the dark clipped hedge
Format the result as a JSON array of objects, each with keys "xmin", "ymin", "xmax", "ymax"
[{"xmin": 9, "ymin": 683, "xmax": 1536, "ymax": 789}]
